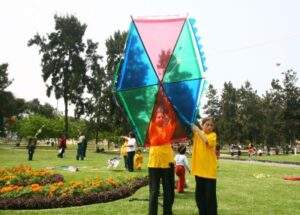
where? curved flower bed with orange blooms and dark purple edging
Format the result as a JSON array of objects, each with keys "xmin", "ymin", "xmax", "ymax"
[{"xmin": 0, "ymin": 166, "xmax": 148, "ymax": 209}]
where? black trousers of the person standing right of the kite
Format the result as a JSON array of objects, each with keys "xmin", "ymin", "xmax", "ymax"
[{"xmin": 195, "ymin": 176, "xmax": 218, "ymax": 215}]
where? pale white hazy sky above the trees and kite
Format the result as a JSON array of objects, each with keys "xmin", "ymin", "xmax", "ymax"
[{"xmin": 0, "ymin": 0, "xmax": 300, "ymax": 114}]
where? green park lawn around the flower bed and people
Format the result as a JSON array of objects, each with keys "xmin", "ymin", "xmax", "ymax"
[{"xmin": 0, "ymin": 145, "xmax": 300, "ymax": 215}]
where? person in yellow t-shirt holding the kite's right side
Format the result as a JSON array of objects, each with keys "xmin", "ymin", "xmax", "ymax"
[{"xmin": 191, "ymin": 117, "xmax": 218, "ymax": 215}]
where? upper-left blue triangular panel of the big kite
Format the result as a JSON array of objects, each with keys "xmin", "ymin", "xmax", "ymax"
[{"xmin": 117, "ymin": 23, "xmax": 158, "ymax": 90}]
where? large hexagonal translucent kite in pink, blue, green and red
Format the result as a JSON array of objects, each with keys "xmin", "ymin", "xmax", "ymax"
[{"xmin": 114, "ymin": 17, "xmax": 207, "ymax": 146}]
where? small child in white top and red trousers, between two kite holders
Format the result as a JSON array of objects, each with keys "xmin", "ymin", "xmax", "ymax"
[{"xmin": 174, "ymin": 145, "xmax": 190, "ymax": 193}]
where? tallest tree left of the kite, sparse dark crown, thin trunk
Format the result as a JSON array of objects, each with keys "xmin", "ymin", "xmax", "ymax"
[{"xmin": 28, "ymin": 15, "xmax": 97, "ymax": 137}]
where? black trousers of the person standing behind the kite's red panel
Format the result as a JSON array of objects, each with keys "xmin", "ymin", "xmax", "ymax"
[{"xmin": 148, "ymin": 164, "xmax": 175, "ymax": 215}]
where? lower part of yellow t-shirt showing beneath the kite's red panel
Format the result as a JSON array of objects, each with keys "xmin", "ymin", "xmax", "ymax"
[{"xmin": 148, "ymin": 144, "xmax": 174, "ymax": 168}]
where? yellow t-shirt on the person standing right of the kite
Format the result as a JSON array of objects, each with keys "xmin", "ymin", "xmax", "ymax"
[{"xmin": 191, "ymin": 131, "xmax": 217, "ymax": 179}]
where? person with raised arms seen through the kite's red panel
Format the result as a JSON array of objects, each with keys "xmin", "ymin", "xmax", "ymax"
[{"xmin": 148, "ymin": 102, "xmax": 175, "ymax": 215}]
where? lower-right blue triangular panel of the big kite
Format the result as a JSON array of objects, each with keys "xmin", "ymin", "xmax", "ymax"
[{"xmin": 163, "ymin": 79, "xmax": 202, "ymax": 124}]
